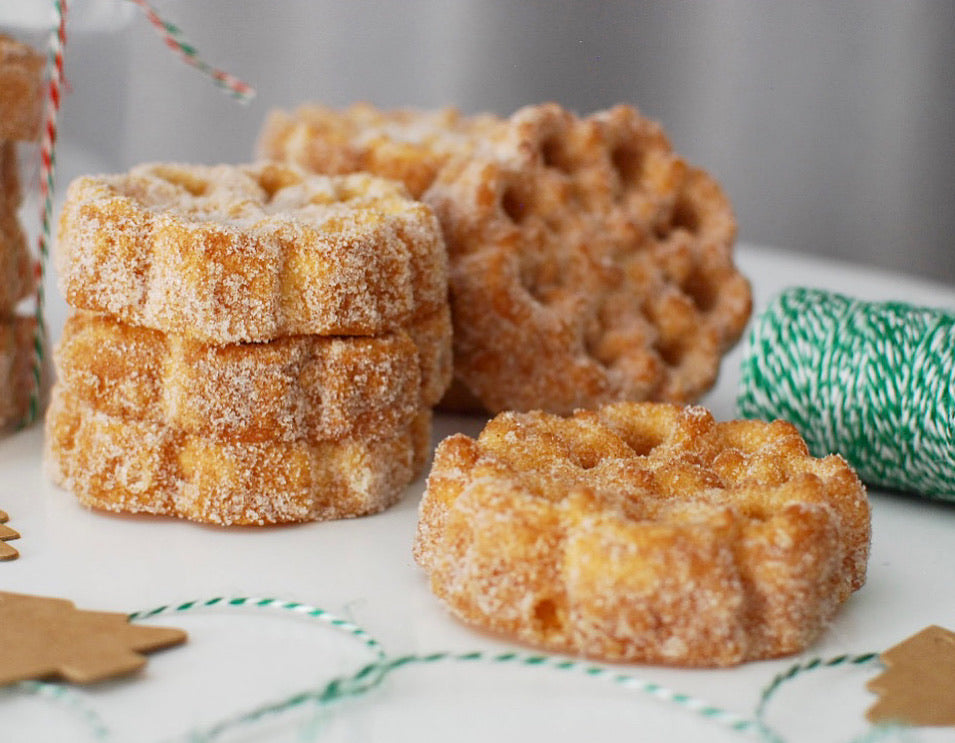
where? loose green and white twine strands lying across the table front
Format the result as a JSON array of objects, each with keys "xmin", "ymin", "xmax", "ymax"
[{"xmin": 5, "ymin": 597, "xmax": 920, "ymax": 743}]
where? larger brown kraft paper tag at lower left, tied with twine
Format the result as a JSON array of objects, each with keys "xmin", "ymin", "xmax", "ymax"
[{"xmin": 0, "ymin": 591, "xmax": 186, "ymax": 685}]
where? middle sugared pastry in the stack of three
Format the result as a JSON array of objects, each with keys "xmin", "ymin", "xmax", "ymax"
[{"xmin": 54, "ymin": 312, "xmax": 451, "ymax": 442}]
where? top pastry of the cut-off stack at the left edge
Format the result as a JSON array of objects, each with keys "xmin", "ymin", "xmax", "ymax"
[{"xmin": 0, "ymin": 34, "xmax": 44, "ymax": 140}]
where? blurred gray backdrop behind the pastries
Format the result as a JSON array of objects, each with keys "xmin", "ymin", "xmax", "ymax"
[{"xmin": 13, "ymin": 0, "xmax": 955, "ymax": 282}]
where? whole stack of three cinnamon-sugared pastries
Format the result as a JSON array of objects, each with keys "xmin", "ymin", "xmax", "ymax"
[{"xmin": 46, "ymin": 163, "xmax": 451, "ymax": 524}]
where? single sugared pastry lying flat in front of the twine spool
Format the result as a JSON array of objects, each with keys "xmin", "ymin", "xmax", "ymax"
[{"xmin": 414, "ymin": 402, "xmax": 870, "ymax": 666}]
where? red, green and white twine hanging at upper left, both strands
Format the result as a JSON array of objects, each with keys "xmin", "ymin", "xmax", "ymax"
[{"xmin": 20, "ymin": 0, "xmax": 255, "ymax": 427}]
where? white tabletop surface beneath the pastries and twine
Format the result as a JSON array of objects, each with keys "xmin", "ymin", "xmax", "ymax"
[{"xmin": 0, "ymin": 246, "xmax": 955, "ymax": 742}]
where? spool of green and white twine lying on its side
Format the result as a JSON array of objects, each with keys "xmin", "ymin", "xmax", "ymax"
[{"xmin": 737, "ymin": 288, "xmax": 955, "ymax": 501}]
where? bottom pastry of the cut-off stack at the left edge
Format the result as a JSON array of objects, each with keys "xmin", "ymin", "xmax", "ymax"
[{"xmin": 0, "ymin": 317, "xmax": 37, "ymax": 430}]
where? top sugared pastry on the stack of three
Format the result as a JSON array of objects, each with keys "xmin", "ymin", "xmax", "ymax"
[{"xmin": 55, "ymin": 163, "xmax": 447, "ymax": 344}]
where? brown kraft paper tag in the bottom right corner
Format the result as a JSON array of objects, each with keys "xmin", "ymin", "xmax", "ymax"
[{"xmin": 866, "ymin": 626, "xmax": 955, "ymax": 725}]
